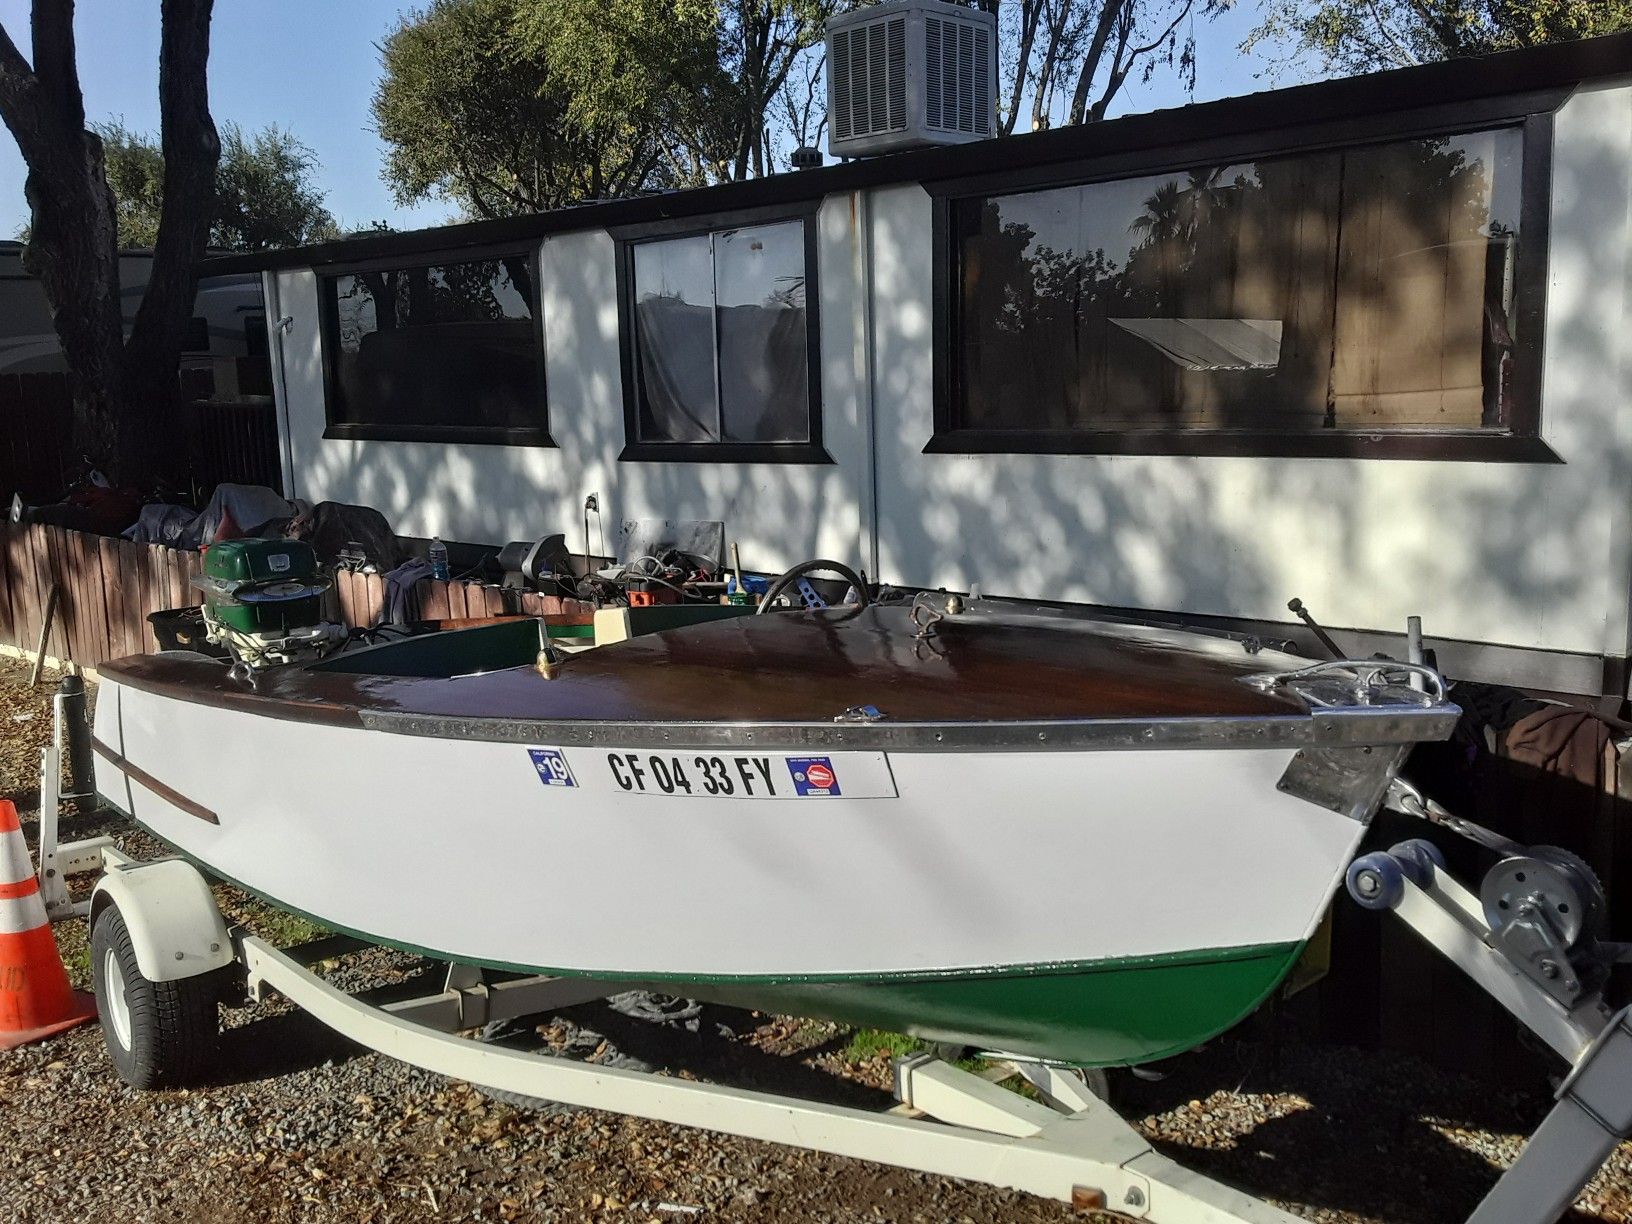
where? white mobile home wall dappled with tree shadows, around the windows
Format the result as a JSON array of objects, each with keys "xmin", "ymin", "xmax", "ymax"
[{"xmin": 266, "ymin": 78, "xmax": 1632, "ymax": 692}]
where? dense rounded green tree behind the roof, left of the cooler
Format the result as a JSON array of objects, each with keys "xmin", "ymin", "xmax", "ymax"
[{"xmin": 374, "ymin": 0, "xmax": 691, "ymax": 217}]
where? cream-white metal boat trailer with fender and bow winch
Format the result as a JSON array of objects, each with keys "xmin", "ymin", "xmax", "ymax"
[{"xmin": 39, "ymin": 749, "xmax": 1632, "ymax": 1224}]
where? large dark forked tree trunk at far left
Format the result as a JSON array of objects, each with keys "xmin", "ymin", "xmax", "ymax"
[{"xmin": 0, "ymin": 0, "xmax": 220, "ymax": 483}]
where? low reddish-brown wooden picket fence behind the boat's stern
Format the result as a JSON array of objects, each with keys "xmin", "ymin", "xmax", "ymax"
[{"xmin": 0, "ymin": 524, "xmax": 589, "ymax": 667}]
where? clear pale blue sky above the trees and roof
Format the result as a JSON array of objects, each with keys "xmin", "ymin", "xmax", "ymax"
[{"xmin": 0, "ymin": 0, "xmax": 1299, "ymax": 238}]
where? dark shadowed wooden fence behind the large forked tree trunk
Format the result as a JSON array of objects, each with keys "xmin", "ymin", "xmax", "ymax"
[{"xmin": 0, "ymin": 359, "xmax": 282, "ymax": 506}]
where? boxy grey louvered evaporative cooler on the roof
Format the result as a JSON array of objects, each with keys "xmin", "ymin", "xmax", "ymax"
[{"xmin": 827, "ymin": 0, "xmax": 997, "ymax": 157}]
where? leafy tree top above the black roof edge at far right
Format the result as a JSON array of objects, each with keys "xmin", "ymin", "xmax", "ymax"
[{"xmin": 1244, "ymin": 0, "xmax": 1632, "ymax": 73}]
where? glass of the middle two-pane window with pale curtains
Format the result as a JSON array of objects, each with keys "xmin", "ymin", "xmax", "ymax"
[{"xmin": 632, "ymin": 220, "xmax": 811, "ymax": 442}]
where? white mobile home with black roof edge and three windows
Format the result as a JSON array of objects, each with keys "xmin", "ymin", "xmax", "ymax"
[{"xmin": 204, "ymin": 38, "xmax": 1632, "ymax": 697}]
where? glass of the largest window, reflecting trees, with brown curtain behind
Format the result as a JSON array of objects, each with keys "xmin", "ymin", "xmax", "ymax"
[{"xmin": 950, "ymin": 129, "xmax": 1523, "ymax": 432}]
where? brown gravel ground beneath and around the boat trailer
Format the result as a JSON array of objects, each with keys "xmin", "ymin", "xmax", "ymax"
[{"xmin": 0, "ymin": 659, "xmax": 1632, "ymax": 1224}]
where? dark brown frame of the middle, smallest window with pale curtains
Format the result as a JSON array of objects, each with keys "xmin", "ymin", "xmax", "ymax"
[{"xmin": 607, "ymin": 199, "xmax": 834, "ymax": 465}]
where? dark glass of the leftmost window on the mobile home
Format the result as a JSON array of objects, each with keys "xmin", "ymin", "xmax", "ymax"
[{"xmin": 323, "ymin": 253, "xmax": 545, "ymax": 431}]
